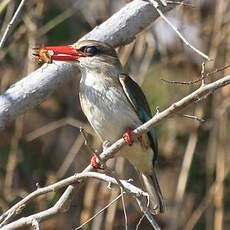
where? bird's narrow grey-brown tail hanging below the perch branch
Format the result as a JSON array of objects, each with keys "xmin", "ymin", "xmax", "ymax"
[{"xmin": 141, "ymin": 170, "xmax": 165, "ymax": 214}]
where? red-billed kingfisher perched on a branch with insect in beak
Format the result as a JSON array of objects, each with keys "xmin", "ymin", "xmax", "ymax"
[{"xmin": 34, "ymin": 40, "xmax": 165, "ymax": 214}]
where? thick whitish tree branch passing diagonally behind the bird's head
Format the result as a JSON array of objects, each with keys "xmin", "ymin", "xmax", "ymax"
[{"xmin": 0, "ymin": 0, "xmax": 182, "ymax": 129}]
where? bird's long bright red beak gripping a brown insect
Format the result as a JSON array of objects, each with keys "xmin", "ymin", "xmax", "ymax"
[{"xmin": 34, "ymin": 45, "xmax": 86, "ymax": 63}]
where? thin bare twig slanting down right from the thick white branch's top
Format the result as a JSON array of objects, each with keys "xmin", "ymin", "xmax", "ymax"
[{"xmin": 149, "ymin": 0, "xmax": 211, "ymax": 61}]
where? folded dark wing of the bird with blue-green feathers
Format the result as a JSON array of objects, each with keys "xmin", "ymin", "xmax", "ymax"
[{"xmin": 119, "ymin": 74, "xmax": 158, "ymax": 160}]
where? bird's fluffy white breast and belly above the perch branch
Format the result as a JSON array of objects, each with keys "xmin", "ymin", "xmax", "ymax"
[{"xmin": 80, "ymin": 73, "xmax": 141, "ymax": 142}]
